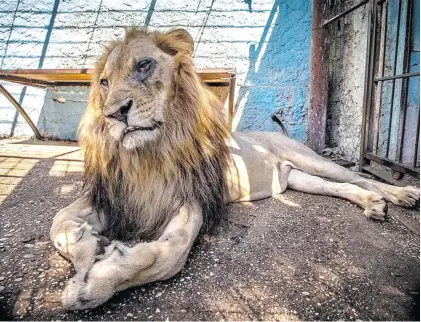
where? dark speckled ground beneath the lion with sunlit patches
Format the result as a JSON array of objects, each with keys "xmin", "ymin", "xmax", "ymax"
[{"xmin": 0, "ymin": 140, "xmax": 420, "ymax": 320}]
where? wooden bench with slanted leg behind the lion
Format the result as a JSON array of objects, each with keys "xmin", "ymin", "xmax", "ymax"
[{"xmin": 0, "ymin": 68, "xmax": 236, "ymax": 139}]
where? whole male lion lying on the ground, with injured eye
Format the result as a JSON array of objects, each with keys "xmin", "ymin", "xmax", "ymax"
[{"xmin": 50, "ymin": 29, "xmax": 419, "ymax": 310}]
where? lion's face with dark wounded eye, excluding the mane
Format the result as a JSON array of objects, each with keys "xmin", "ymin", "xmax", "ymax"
[{"xmin": 98, "ymin": 35, "xmax": 174, "ymax": 149}]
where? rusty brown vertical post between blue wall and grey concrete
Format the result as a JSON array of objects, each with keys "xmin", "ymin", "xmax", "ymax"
[{"xmin": 307, "ymin": 0, "xmax": 327, "ymax": 153}]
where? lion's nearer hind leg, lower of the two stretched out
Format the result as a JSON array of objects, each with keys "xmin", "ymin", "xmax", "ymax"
[{"xmin": 288, "ymin": 169, "xmax": 387, "ymax": 220}]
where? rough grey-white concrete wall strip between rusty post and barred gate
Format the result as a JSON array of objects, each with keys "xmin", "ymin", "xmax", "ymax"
[{"xmin": 326, "ymin": 0, "xmax": 367, "ymax": 161}]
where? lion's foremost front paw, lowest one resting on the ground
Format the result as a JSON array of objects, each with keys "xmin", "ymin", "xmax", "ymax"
[{"xmin": 61, "ymin": 274, "xmax": 114, "ymax": 310}]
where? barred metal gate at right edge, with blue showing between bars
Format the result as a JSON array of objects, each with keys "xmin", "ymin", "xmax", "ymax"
[{"xmin": 360, "ymin": 0, "xmax": 420, "ymax": 183}]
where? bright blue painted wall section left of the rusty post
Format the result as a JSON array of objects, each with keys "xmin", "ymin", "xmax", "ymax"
[{"xmin": 237, "ymin": 0, "xmax": 311, "ymax": 141}]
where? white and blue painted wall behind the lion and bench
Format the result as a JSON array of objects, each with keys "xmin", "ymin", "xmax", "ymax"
[{"xmin": 0, "ymin": 0, "xmax": 311, "ymax": 141}]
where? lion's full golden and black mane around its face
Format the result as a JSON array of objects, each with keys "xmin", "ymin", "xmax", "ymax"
[{"xmin": 78, "ymin": 29, "xmax": 229, "ymax": 239}]
